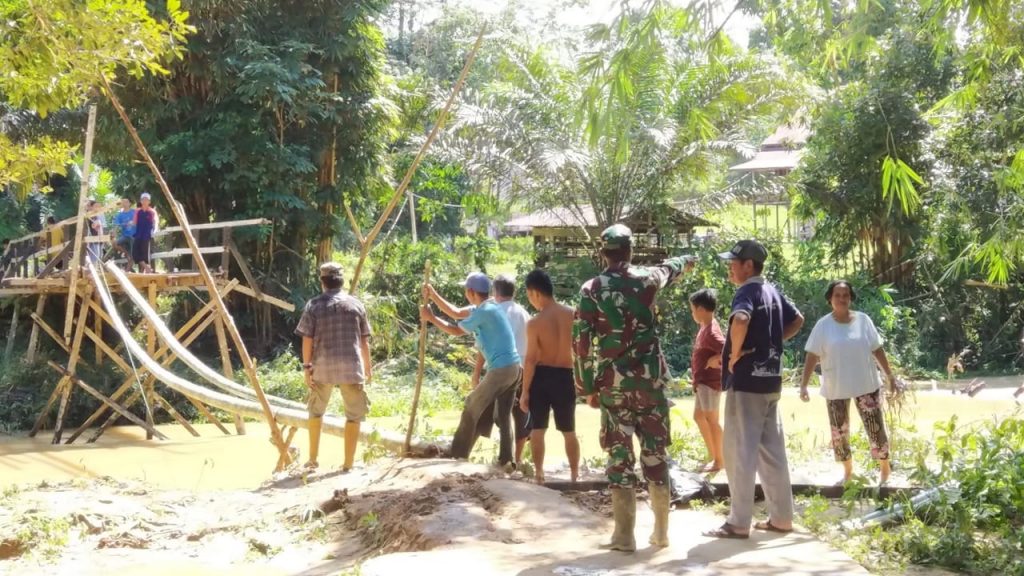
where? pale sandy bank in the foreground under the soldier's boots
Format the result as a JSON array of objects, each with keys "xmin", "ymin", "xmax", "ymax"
[{"xmin": 0, "ymin": 460, "xmax": 866, "ymax": 576}]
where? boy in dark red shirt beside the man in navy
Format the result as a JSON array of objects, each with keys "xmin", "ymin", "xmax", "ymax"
[{"xmin": 690, "ymin": 288, "xmax": 725, "ymax": 474}]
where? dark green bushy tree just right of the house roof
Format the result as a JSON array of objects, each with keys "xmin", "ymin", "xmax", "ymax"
[{"xmin": 799, "ymin": 20, "xmax": 952, "ymax": 285}]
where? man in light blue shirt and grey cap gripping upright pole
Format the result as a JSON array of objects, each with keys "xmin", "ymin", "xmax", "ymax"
[{"xmin": 420, "ymin": 272, "xmax": 522, "ymax": 466}]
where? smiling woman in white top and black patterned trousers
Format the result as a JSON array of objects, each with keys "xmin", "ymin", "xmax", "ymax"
[{"xmin": 800, "ymin": 280, "xmax": 895, "ymax": 484}]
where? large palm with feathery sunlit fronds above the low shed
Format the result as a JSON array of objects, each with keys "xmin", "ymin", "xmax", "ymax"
[{"xmin": 432, "ymin": 2, "xmax": 797, "ymax": 230}]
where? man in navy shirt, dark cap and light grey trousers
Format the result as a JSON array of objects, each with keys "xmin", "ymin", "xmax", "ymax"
[{"xmin": 705, "ymin": 240, "xmax": 804, "ymax": 538}]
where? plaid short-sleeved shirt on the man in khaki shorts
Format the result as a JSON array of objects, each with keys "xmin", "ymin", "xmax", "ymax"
[{"xmin": 295, "ymin": 290, "xmax": 371, "ymax": 384}]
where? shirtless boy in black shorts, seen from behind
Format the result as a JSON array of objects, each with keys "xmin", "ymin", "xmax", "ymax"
[{"xmin": 519, "ymin": 270, "xmax": 580, "ymax": 484}]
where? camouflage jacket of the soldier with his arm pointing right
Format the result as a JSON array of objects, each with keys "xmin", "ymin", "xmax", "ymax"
[{"xmin": 572, "ymin": 257, "xmax": 686, "ymax": 396}]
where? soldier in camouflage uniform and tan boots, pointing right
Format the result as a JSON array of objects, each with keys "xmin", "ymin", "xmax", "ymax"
[{"xmin": 572, "ymin": 224, "xmax": 692, "ymax": 551}]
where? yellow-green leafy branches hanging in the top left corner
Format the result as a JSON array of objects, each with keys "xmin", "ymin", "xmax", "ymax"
[{"xmin": 0, "ymin": 0, "xmax": 190, "ymax": 194}]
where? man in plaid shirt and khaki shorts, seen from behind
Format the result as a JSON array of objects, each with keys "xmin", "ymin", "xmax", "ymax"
[{"xmin": 295, "ymin": 262, "xmax": 373, "ymax": 471}]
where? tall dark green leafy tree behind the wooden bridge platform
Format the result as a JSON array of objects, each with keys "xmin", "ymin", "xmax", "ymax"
[{"xmin": 96, "ymin": 0, "xmax": 394, "ymax": 330}]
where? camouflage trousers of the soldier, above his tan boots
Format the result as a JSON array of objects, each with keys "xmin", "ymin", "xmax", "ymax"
[{"xmin": 601, "ymin": 390, "xmax": 672, "ymax": 488}]
